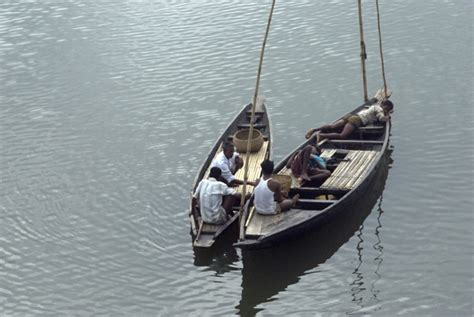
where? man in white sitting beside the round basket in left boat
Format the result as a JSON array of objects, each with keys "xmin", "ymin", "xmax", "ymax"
[{"xmin": 211, "ymin": 141, "xmax": 255, "ymax": 187}]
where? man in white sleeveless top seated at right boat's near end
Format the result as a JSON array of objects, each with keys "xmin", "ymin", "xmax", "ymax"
[{"xmin": 253, "ymin": 160, "xmax": 299, "ymax": 215}]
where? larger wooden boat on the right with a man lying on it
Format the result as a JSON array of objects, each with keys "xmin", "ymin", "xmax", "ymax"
[{"xmin": 234, "ymin": 91, "xmax": 390, "ymax": 249}]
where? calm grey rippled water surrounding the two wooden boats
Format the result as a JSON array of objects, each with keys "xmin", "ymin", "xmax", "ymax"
[{"xmin": 0, "ymin": 0, "xmax": 474, "ymax": 316}]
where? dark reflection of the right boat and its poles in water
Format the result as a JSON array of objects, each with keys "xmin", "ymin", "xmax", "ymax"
[{"xmin": 236, "ymin": 147, "xmax": 392, "ymax": 316}]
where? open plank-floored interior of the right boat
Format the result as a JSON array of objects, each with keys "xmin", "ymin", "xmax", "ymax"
[{"xmin": 245, "ymin": 118, "xmax": 385, "ymax": 238}]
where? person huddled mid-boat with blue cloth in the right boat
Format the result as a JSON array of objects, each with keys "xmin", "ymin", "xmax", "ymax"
[{"xmin": 286, "ymin": 145, "xmax": 331, "ymax": 184}]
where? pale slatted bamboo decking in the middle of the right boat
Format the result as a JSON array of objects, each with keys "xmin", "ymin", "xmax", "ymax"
[{"xmin": 321, "ymin": 151, "xmax": 378, "ymax": 190}]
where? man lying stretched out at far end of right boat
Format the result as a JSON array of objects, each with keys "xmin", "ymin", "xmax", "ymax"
[{"xmin": 305, "ymin": 100, "xmax": 393, "ymax": 144}]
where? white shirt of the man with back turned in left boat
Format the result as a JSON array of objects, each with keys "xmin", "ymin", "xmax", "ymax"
[{"xmin": 193, "ymin": 177, "xmax": 235, "ymax": 224}]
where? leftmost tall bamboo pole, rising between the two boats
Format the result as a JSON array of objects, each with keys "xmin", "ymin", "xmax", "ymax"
[{"xmin": 239, "ymin": 0, "xmax": 276, "ymax": 240}]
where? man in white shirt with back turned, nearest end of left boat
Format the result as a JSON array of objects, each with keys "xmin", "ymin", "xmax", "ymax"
[{"xmin": 191, "ymin": 167, "xmax": 240, "ymax": 224}]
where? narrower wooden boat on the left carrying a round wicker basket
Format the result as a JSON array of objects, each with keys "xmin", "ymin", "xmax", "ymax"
[{"xmin": 189, "ymin": 99, "xmax": 272, "ymax": 248}]
